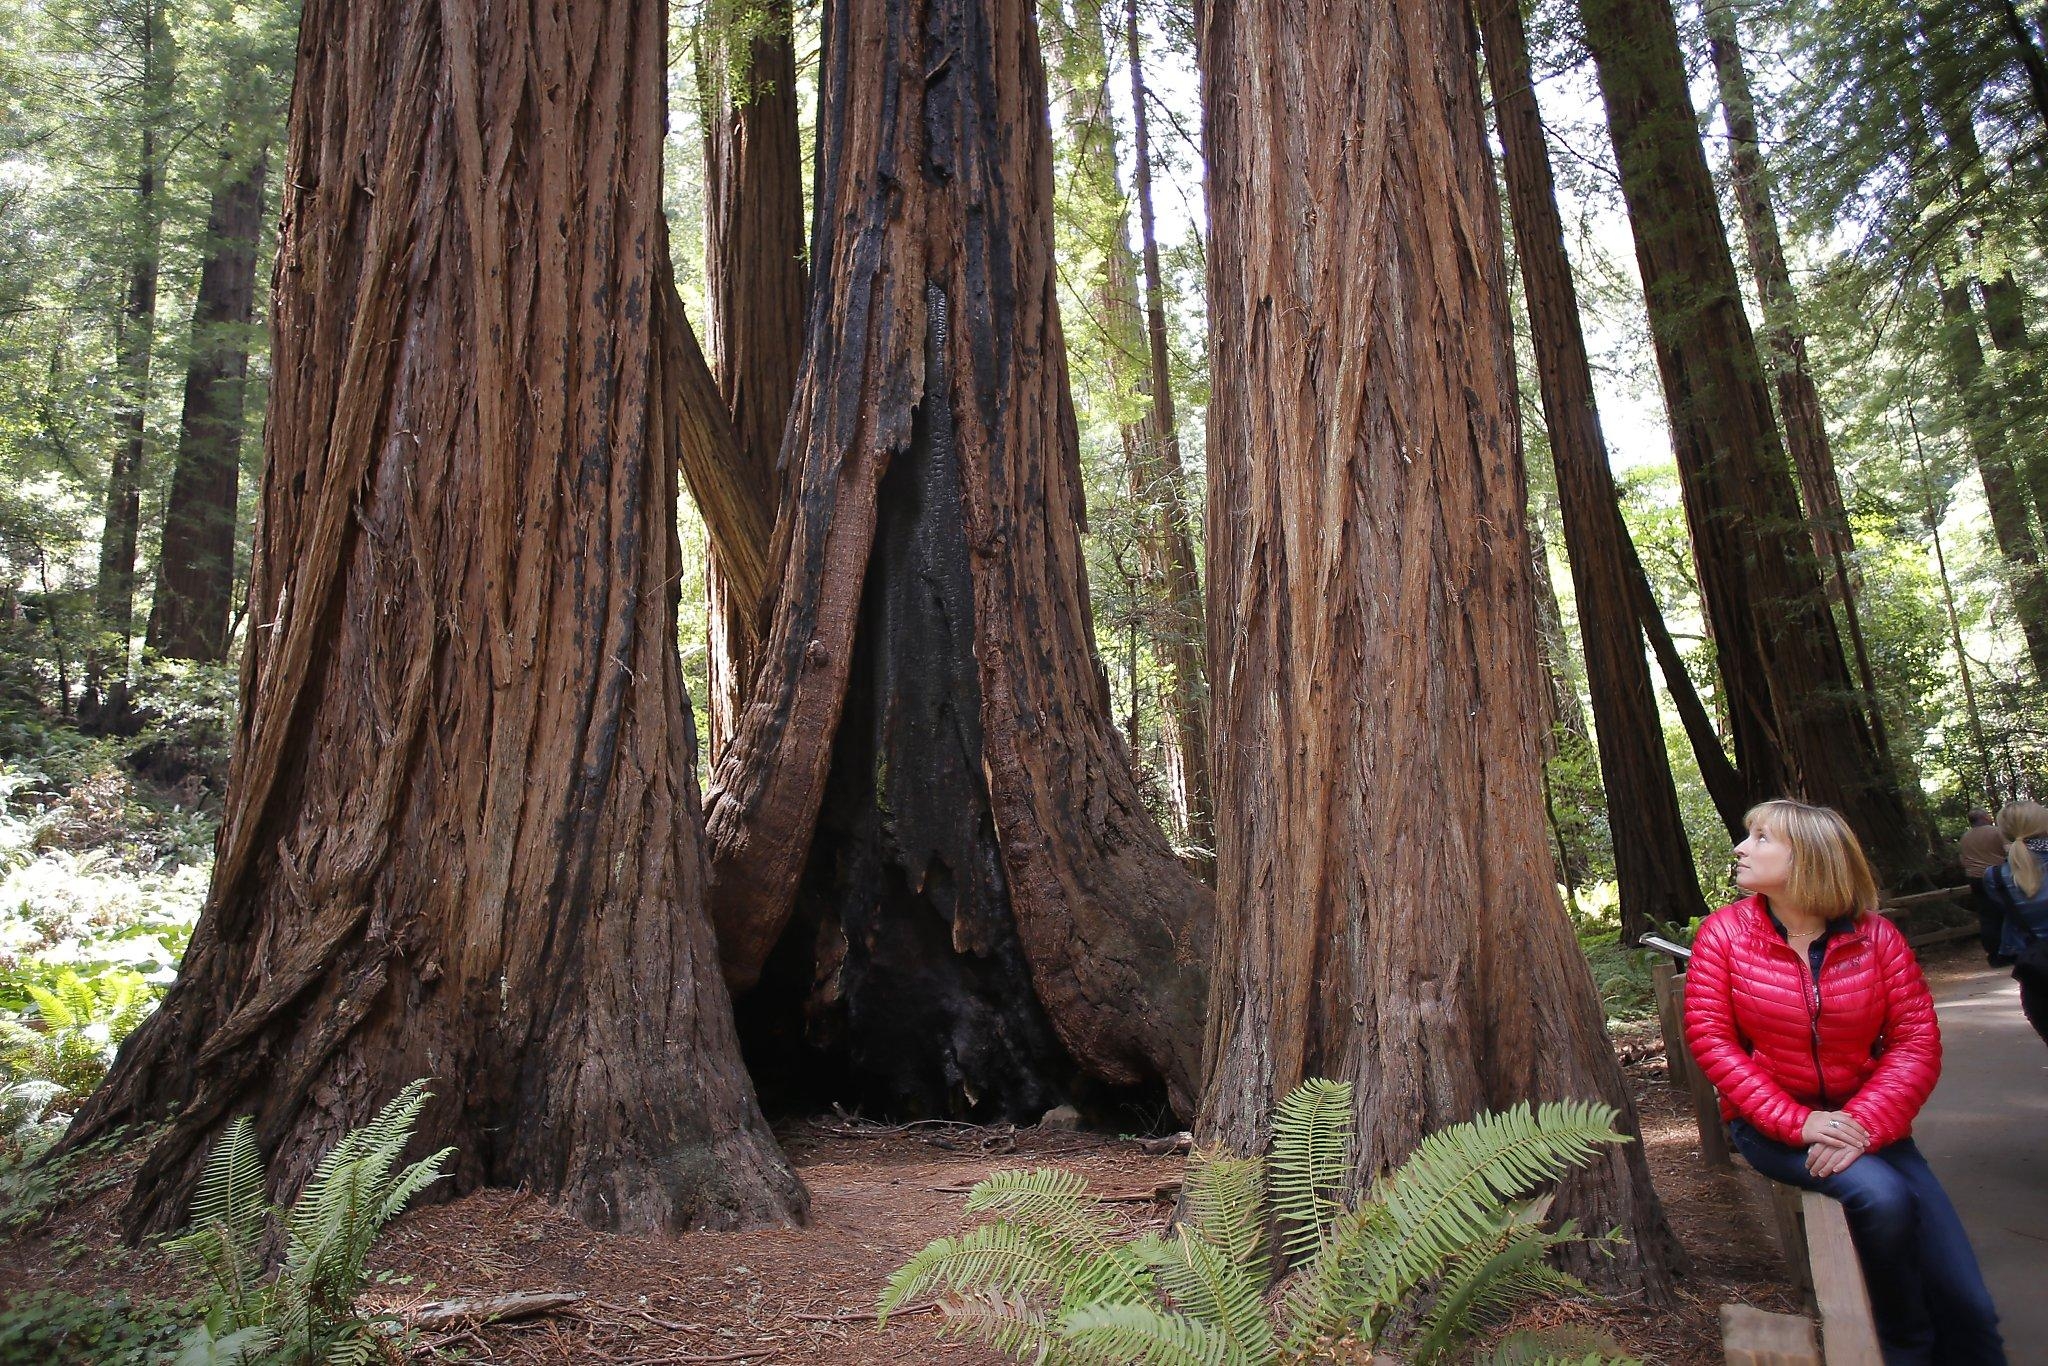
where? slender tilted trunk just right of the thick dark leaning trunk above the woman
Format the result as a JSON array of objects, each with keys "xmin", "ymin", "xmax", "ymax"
[{"xmin": 1700, "ymin": 0, "xmax": 1890, "ymax": 754}]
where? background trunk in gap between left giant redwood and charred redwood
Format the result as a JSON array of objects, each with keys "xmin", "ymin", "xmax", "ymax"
[{"xmin": 702, "ymin": 0, "xmax": 809, "ymax": 758}]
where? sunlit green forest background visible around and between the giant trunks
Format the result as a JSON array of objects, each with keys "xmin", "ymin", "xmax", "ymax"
[{"xmin": 0, "ymin": 0, "xmax": 2048, "ymax": 1302}]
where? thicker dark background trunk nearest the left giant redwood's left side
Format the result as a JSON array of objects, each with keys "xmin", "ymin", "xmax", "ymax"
[{"xmin": 147, "ymin": 154, "xmax": 266, "ymax": 661}]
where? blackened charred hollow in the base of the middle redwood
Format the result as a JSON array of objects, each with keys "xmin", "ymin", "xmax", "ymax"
[{"xmin": 739, "ymin": 287, "xmax": 1075, "ymax": 1120}]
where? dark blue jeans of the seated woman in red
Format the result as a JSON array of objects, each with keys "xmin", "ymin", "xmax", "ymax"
[{"xmin": 1729, "ymin": 1120, "xmax": 2005, "ymax": 1366}]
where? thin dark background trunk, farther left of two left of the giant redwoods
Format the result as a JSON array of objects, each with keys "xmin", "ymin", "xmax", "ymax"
[{"xmin": 86, "ymin": 0, "xmax": 172, "ymax": 729}]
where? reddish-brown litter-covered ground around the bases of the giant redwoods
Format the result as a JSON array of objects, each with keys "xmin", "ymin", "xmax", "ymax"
[{"xmin": 0, "ymin": 983, "xmax": 1900, "ymax": 1366}]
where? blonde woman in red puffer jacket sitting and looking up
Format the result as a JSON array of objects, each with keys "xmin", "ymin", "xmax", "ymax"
[{"xmin": 1686, "ymin": 801, "xmax": 2005, "ymax": 1366}]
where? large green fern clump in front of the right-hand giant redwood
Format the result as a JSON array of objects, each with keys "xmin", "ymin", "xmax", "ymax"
[{"xmin": 879, "ymin": 1081, "xmax": 1622, "ymax": 1366}]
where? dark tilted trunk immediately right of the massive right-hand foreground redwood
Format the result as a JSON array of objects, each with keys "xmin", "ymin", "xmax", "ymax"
[{"xmin": 1479, "ymin": 0, "xmax": 1718, "ymax": 944}]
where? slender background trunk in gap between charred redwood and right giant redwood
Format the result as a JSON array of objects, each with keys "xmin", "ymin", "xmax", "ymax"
[{"xmin": 1124, "ymin": 0, "xmax": 1217, "ymax": 850}]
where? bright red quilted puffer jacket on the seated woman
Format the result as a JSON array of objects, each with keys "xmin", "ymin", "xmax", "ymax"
[{"xmin": 1686, "ymin": 897, "xmax": 1942, "ymax": 1149}]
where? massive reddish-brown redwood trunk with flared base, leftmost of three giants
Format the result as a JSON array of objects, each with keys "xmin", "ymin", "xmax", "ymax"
[{"xmin": 72, "ymin": 0, "xmax": 803, "ymax": 1233}]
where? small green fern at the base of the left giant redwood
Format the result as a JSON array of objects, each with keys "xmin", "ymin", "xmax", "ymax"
[{"xmin": 166, "ymin": 1081, "xmax": 455, "ymax": 1366}]
